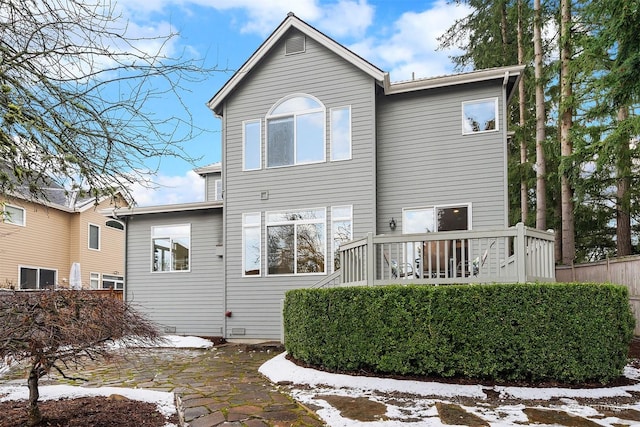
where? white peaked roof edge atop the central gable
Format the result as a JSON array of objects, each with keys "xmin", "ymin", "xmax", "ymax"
[{"xmin": 207, "ymin": 12, "xmax": 387, "ymax": 115}]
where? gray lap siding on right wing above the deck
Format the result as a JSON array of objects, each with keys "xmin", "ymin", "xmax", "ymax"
[{"xmin": 377, "ymin": 81, "xmax": 507, "ymax": 234}]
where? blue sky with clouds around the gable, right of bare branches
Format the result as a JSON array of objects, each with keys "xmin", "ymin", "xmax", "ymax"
[{"xmin": 119, "ymin": 0, "xmax": 469, "ymax": 206}]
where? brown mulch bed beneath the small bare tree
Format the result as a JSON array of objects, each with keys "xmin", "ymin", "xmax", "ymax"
[{"xmin": 0, "ymin": 397, "xmax": 178, "ymax": 427}]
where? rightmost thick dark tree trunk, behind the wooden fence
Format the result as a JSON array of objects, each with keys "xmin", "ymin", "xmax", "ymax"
[{"xmin": 616, "ymin": 107, "xmax": 632, "ymax": 256}]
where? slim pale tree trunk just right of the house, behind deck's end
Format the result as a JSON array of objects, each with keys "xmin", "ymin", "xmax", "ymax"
[{"xmin": 533, "ymin": 0, "xmax": 547, "ymax": 230}]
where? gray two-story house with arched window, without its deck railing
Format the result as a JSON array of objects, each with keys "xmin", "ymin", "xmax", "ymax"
[{"xmin": 111, "ymin": 14, "xmax": 544, "ymax": 339}]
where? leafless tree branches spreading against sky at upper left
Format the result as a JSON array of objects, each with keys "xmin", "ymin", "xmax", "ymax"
[{"xmin": 0, "ymin": 0, "xmax": 219, "ymax": 204}]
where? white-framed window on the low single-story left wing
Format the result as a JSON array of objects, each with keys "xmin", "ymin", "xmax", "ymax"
[{"xmin": 151, "ymin": 224, "xmax": 191, "ymax": 272}]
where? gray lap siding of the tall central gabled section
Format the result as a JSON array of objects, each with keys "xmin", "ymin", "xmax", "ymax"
[{"xmin": 223, "ymin": 28, "xmax": 376, "ymax": 339}]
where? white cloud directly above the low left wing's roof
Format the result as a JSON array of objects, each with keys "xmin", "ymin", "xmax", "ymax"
[{"xmin": 131, "ymin": 170, "xmax": 204, "ymax": 206}]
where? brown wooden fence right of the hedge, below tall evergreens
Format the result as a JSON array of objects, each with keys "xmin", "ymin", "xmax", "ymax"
[{"xmin": 556, "ymin": 255, "xmax": 640, "ymax": 335}]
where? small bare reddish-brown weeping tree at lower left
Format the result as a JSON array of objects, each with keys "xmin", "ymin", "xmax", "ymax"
[{"xmin": 0, "ymin": 290, "xmax": 161, "ymax": 425}]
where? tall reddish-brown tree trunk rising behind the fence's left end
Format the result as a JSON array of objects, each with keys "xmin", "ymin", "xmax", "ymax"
[{"xmin": 560, "ymin": 0, "xmax": 576, "ymax": 265}]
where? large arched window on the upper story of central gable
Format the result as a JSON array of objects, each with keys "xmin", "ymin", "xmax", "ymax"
[{"xmin": 267, "ymin": 95, "xmax": 325, "ymax": 167}]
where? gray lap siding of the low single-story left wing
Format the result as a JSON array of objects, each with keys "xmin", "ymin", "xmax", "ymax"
[{"xmin": 126, "ymin": 209, "xmax": 224, "ymax": 336}]
